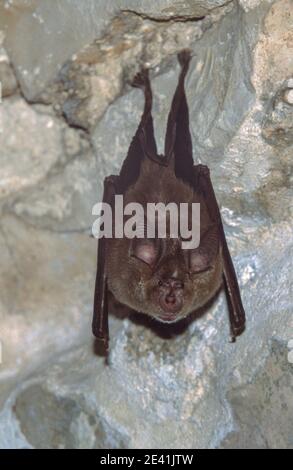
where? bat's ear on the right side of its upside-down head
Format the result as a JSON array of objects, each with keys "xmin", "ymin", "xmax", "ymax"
[{"xmin": 188, "ymin": 224, "xmax": 219, "ymax": 273}]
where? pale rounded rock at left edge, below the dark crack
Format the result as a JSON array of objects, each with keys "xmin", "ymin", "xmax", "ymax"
[{"xmin": 0, "ymin": 97, "xmax": 70, "ymax": 200}]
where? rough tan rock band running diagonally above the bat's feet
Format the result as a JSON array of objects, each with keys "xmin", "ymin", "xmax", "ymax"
[{"xmin": 38, "ymin": 5, "xmax": 232, "ymax": 130}]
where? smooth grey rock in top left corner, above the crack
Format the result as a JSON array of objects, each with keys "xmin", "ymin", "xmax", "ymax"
[{"xmin": 0, "ymin": 0, "xmax": 231, "ymax": 99}]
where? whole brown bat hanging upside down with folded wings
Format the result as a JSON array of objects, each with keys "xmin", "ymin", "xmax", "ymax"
[{"xmin": 93, "ymin": 50, "xmax": 245, "ymax": 348}]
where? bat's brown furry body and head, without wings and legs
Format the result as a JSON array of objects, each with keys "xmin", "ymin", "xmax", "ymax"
[{"xmin": 107, "ymin": 165, "xmax": 222, "ymax": 323}]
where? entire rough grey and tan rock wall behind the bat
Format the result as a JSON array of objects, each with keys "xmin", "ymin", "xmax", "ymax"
[{"xmin": 0, "ymin": 0, "xmax": 293, "ymax": 449}]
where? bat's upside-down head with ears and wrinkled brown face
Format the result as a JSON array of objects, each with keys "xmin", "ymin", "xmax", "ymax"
[{"xmin": 109, "ymin": 226, "xmax": 222, "ymax": 323}]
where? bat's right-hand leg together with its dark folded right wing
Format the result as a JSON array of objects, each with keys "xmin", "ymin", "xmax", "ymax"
[{"xmin": 165, "ymin": 50, "xmax": 245, "ymax": 341}]
